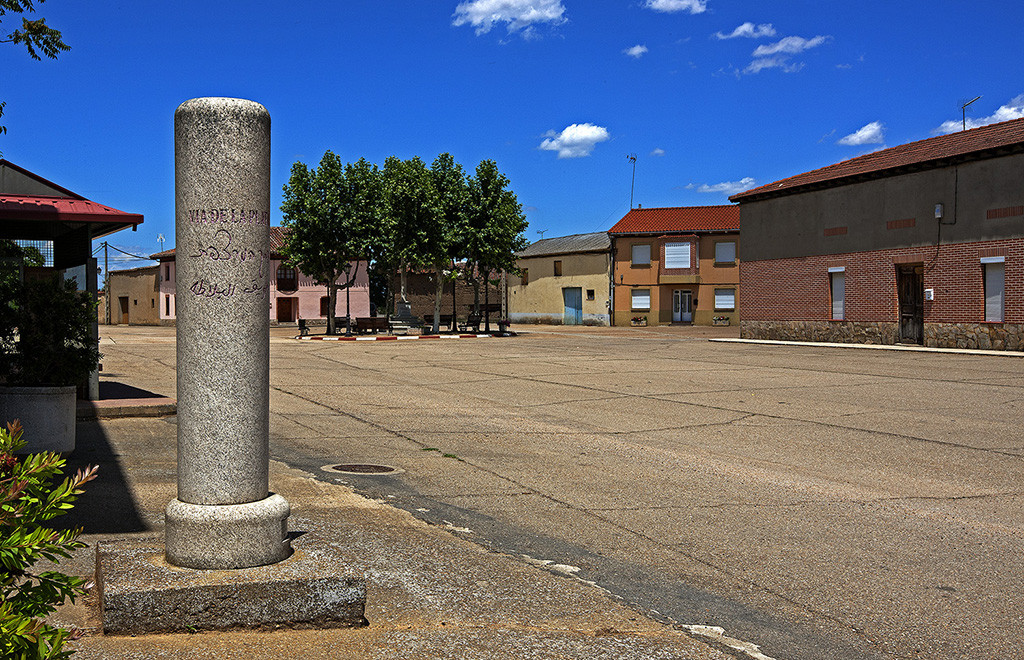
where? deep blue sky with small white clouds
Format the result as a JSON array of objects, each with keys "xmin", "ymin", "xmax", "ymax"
[{"xmin": 0, "ymin": 0, "xmax": 1024, "ymax": 266}]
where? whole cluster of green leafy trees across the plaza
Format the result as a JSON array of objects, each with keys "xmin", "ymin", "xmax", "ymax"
[{"xmin": 281, "ymin": 151, "xmax": 527, "ymax": 334}]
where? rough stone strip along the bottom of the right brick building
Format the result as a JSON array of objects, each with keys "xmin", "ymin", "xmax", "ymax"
[{"xmin": 739, "ymin": 321, "xmax": 1024, "ymax": 351}]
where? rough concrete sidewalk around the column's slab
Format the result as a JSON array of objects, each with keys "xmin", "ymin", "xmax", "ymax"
[{"xmin": 57, "ymin": 416, "xmax": 741, "ymax": 660}]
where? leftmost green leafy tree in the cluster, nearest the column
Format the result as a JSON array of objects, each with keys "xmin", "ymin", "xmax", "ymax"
[{"xmin": 281, "ymin": 150, "xmax": 382, "ymax": 335}]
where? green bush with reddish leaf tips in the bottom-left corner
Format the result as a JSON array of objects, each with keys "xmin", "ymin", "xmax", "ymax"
[{"xmin": 0, "ymin": 421, "xmax": 96, "ymax": 659}]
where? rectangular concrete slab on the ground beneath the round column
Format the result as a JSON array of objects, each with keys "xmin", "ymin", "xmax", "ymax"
[{"xmin": 96, "ymin": 538, "xmax": 367, "ymax": 634}]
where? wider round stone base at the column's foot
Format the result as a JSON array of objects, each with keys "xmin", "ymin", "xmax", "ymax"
[{"xmin": 166, "ymin": 494, "xmax": 292, "ymax": 569}]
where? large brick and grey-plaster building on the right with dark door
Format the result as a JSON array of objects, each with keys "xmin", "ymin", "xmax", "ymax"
[{"xmin": 730, "ymin": 119, "xmax": 1024, "ymax": 350}]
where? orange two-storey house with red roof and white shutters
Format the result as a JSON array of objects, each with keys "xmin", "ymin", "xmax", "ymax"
[{"xmin": 608, "ymin": 205, "xmax": 745, "ymax": 325}]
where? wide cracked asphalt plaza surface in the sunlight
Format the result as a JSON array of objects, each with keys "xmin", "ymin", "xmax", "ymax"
[{"xmin": 68, "ymin": 326, "xmax": 1024, "ymax": 659}]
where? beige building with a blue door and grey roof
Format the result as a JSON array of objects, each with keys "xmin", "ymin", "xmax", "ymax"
[{"xmin": 508, "ymin": 231, "xmax": 611, "ymax": 325}]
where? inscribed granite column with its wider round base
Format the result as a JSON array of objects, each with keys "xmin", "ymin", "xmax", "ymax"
[{"xmin": 166, "ymin": 98, "xmax": 291, "ymax": 569}]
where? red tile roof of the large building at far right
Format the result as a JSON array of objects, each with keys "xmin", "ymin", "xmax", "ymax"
[{"xmin": 729, "ymin": 119, "xmax": 1024, "ymax": 202}]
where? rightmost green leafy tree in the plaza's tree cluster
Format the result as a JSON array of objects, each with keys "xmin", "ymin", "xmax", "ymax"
[{"xmin": 463, "ymin": 160, "xmax": 528, "ymax": 319}]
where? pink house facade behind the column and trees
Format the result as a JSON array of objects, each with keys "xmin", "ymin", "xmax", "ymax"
[{"xmin": 150, "ymin": 227, "xmax": 370, "ymax": 324}]
